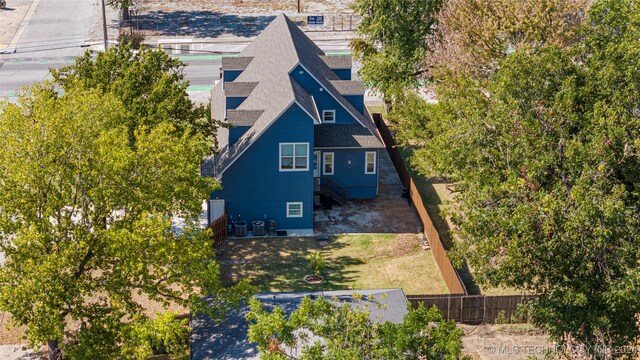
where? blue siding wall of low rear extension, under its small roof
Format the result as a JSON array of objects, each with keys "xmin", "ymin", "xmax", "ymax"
[{"xmin": 320, "ymin": 149, "xmax": 380, "ymax": 199}]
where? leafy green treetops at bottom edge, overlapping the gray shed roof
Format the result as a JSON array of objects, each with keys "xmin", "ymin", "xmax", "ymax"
[{"xmin": 247, "ymin": 297, "xmax": 462, "ymax": 360}]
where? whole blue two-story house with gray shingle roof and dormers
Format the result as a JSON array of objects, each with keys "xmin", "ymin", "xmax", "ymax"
[{"xmin": 203, "ymin": 15, "xmax": 383, "ymax": 235}]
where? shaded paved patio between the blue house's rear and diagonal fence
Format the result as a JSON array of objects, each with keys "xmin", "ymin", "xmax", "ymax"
[{"xmin": 314, "ymin": 150, "xmax": 422, "ymax": 236}]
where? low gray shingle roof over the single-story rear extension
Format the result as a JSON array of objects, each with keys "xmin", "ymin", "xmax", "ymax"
[{"xmin": 313, "ymin": 124, "xmax": 384, "ymax": 149}]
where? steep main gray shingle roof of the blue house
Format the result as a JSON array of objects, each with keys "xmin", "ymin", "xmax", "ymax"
[{"xmin": 212, "ymin": 14, "xmax": 377, "ymax": 176}]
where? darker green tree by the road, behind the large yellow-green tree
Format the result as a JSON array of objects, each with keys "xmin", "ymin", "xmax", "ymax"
[{"xmin": 51, "ymin": 44, "xmax": 215, "ymax": 148}]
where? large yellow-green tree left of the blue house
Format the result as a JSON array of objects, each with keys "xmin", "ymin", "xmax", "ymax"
[{"xmin": 0, "ymin": 78, "xmax": 247, "ymax": 359}]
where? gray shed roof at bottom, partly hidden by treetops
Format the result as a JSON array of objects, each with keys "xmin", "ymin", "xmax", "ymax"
[{"xmin": 189, "ymin": 289, "xmax": 408, "ymax": 360}]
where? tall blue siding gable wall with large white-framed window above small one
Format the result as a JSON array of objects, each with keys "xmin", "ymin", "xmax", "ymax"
[{"xmin": 211, "ymin": 104, "xmax": 316, "ymax": 229}]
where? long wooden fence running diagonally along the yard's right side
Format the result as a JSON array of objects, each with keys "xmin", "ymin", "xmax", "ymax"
[{"xmin": 373, "ymin": 114, "xmax": 467, "ymax": 294}]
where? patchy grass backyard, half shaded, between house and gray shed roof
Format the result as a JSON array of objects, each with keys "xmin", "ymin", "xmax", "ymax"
[{"xmin": 218, "ymin": 234, "xmax": 447, "ymax": 294}]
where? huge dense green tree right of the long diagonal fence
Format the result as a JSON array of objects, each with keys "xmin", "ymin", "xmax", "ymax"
[{"xmin": 392, "ymin": 0, "xmax": 640, "ymax": 358}]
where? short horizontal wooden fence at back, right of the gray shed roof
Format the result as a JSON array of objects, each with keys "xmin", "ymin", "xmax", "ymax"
[{"xmin": 407, "ymin": 295, "xmax": 536, "ymax": 324}]
